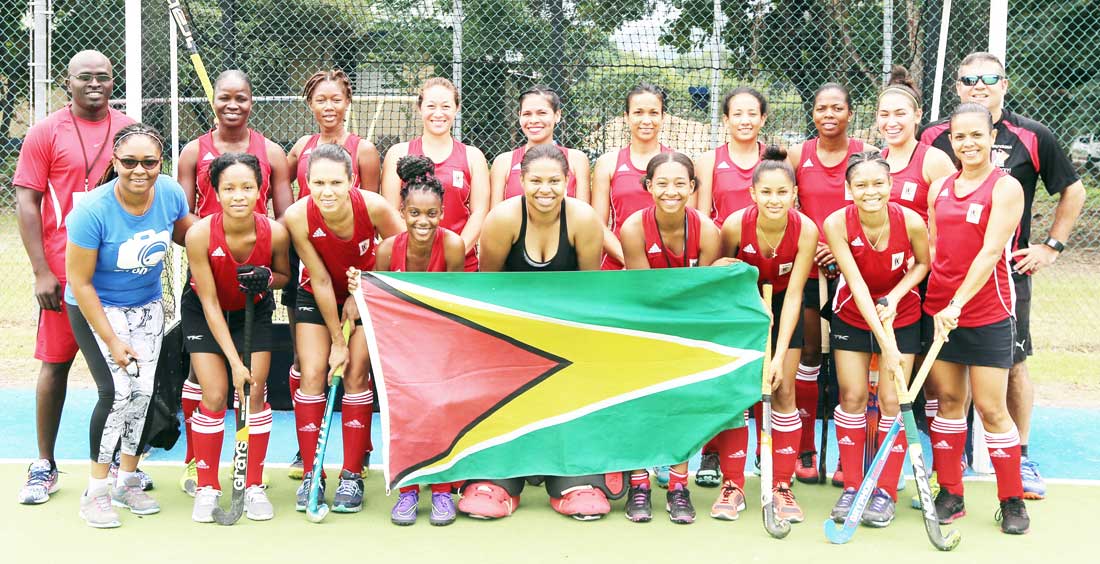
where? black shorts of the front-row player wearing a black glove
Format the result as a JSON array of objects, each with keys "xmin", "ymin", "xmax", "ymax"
[{"xmin": 179, "ymin": 286, "xmax": 275, "ymax": 354}]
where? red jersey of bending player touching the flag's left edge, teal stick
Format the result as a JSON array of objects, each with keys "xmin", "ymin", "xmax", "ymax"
[{"xmin": 299, "ymin": 190, "xmax": 374, "ymax": 303}]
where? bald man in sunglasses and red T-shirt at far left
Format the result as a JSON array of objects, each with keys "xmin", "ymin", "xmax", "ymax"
[{"xmin": 12, "ymin": 51, "xmax": 134, "ymax": 504}]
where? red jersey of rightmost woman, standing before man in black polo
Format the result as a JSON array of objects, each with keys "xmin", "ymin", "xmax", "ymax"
[{"xmin": 924, "ymin": 168, "xmax": 1015, "ymax": 327}]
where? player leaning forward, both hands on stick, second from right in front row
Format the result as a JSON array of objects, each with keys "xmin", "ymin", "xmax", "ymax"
[{"xmin": 825, "ymin": 151, "xmax": 931, "ymax": 527}]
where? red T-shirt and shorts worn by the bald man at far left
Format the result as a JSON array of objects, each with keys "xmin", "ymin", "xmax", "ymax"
[{"xmin": 11, "ymin": 107, "xmax": 134, "ymax": 363}]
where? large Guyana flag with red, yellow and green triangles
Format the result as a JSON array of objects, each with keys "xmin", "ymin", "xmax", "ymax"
[{"xmin": 361, "ymin": 264, "xmax": 768, "ymax": 488}]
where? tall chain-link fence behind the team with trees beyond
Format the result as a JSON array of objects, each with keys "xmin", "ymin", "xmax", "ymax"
[{"xmin": 0, "ymin": 0, "xmax": 1100, "ymax": 365}]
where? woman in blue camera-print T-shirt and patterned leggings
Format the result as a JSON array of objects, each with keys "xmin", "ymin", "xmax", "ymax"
[{"xmin": 65, "ymin": 123, "xmax": 194, "ymax": 529}]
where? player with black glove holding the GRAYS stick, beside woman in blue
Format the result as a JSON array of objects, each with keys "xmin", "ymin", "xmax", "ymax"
[{"xmin": 187, "ymin": 153, "xmax": 290, "ymax": 523}]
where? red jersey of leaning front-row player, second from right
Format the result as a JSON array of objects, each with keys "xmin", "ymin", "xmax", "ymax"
[{"xmin": 833, "ymin": 202, "xmax": 921, "ymax": 330}]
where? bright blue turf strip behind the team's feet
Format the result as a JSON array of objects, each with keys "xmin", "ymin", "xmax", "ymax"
[{"xmin": 0, "ymin": 389, "xmax": 1100, "ymax": 479}]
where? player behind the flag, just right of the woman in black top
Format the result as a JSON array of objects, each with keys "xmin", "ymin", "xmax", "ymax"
[{"xmin": 619, "ymin": 153, "xmax": 728, "ymax": 524}]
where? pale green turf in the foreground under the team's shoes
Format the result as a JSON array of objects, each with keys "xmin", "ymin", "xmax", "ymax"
[{"xmin": 0, "ymin": 464, "xmax": 1100, "ymax": 564}]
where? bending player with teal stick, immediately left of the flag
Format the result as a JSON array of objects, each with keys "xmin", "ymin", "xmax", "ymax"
[{"xmin": 285, "ymin": 144, "xmax": 405, "ymax": 513}]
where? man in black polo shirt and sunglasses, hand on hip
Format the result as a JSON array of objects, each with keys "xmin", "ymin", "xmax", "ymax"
[{"xmin": 921, "ymin": 52, "xmax": 1085, "ymax": 499}]
